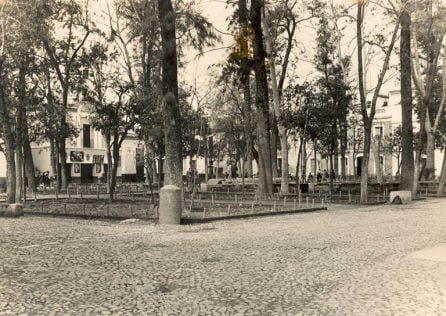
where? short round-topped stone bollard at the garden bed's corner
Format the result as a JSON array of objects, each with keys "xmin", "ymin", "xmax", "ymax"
[{"xmin": 159, "ymin": 185, "xmax": 182, "ymax": 225}]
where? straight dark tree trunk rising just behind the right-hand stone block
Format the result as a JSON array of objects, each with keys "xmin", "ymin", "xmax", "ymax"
[{"xmin": 398, "ymin": 6, "xmax": 415, "ymax": 190}]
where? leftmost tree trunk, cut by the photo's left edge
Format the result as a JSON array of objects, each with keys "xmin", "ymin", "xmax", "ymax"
[{"xmin": 0, "ymin": 56, "xmax": 16, "ymax": 203}]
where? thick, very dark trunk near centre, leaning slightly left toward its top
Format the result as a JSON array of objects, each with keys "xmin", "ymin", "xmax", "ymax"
[{"xmin": 251, "ymin": 0, "xmax": 273, "ymax": 198}]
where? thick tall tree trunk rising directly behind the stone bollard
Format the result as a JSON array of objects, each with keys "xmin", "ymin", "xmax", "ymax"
[{"xmin": 158, "ymin": 0, "xmax": 183, "ymax": 189}]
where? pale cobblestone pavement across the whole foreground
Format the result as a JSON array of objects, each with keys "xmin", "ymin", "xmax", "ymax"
[{"xmin": 0, "ymin": 200, "xmax": 446, "ymax": 315}]
